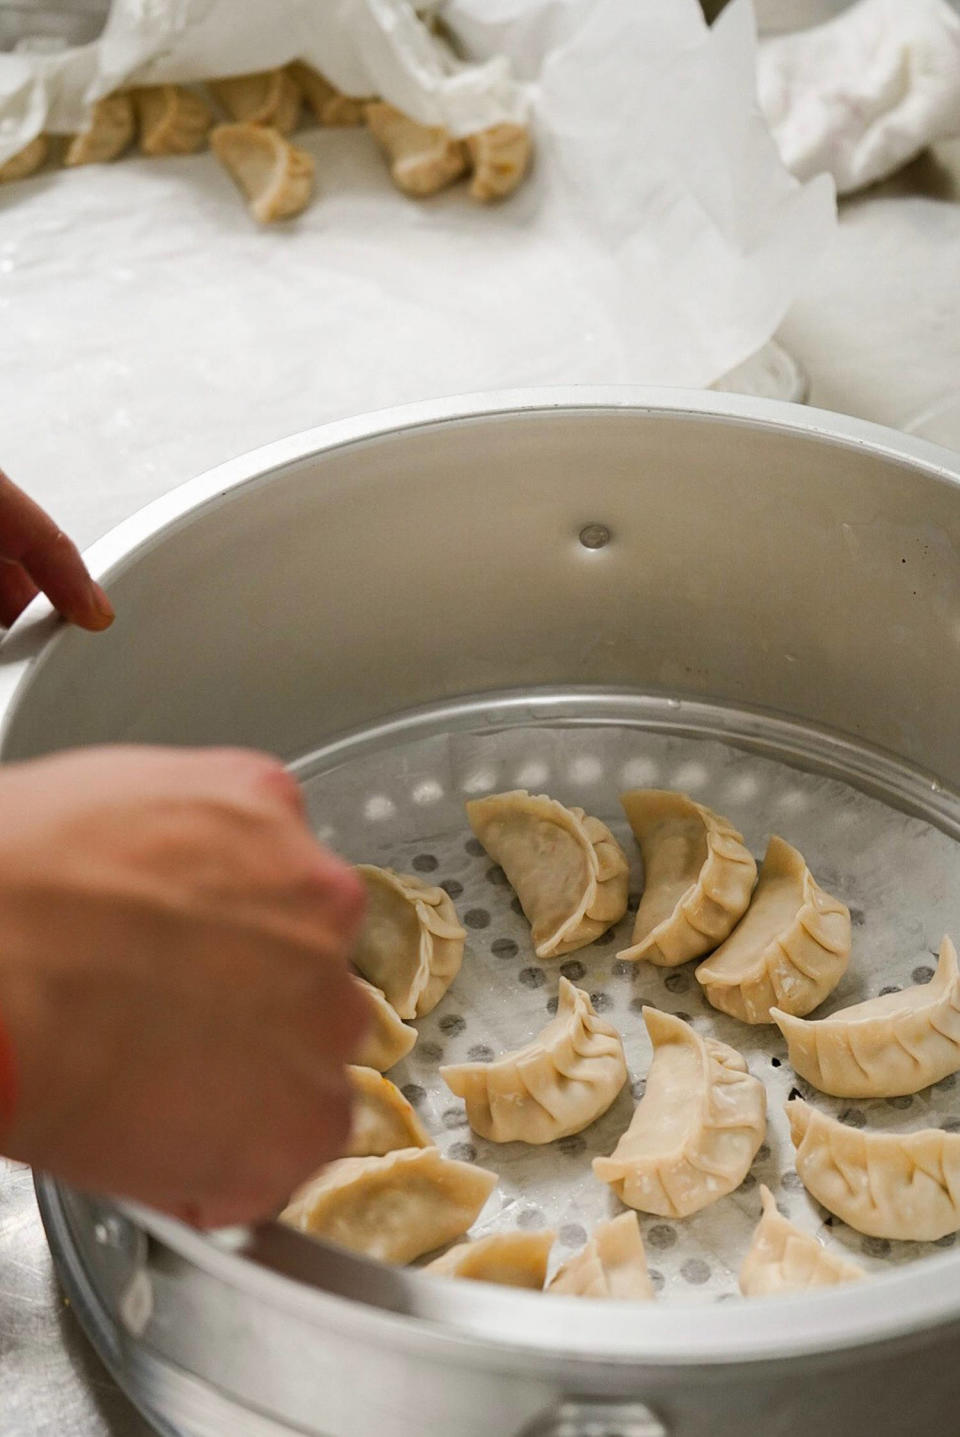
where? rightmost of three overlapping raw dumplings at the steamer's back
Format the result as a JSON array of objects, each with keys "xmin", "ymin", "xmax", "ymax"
[{"xmin": 697, "ymin": 838, "xmax": 851, "ymax": 1023}]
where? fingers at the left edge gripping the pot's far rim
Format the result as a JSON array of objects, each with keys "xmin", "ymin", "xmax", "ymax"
[{"xmin": 0, "ymin": 470, "xmax": 114, "ymax": 629}]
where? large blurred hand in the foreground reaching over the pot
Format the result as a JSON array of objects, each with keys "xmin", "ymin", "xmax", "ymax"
[{"xmin": 0, "ymin": 747, "xmax": 366, "ymax": 1226}]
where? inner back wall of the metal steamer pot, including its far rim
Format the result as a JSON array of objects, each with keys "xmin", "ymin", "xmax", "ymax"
[{"xmin": 0, "ymin": 388, "xmax": 960, "ymax": 783}]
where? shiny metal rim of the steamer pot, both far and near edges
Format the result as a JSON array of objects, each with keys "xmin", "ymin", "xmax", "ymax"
[{"xmin": 11, "ymin": 385, "xmax": 960, "ymax": 1368}]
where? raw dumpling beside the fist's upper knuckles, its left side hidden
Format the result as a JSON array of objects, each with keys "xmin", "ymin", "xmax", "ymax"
[{"xmin": 354, "ymin": 864, "xmax": 467, "ymax": 1017}]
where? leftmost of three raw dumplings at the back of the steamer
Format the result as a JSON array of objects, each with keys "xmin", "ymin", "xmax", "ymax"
[{"xmin": 467, "ymin": 789, "xmax": 629, "ymax": 958}]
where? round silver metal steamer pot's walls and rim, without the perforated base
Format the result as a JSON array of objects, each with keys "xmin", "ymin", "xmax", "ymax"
[{"xmin": 0, "ymin": 389, "xmax": 960, "ymax": 1437}]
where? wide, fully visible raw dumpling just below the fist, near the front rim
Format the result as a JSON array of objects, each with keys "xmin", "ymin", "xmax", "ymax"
[{"xmin": 280, "ymin": 1147, "xmax": 497, "ymax": 1263}]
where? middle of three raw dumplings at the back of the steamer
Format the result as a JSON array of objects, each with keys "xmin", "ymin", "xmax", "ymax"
[{"xmin": 617, "ymin": 789, "xmax": 757, "ymax": 967}]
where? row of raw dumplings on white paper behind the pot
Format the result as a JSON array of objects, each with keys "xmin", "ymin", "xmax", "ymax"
[{"xmin": 0, "ymin": 60, "xmax": 530, "ymax": 224}]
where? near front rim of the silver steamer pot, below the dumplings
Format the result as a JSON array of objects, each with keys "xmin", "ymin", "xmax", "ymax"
[{"xmin": 119, "ymin": 1203, "xmax": 960, "ymax": 1371}]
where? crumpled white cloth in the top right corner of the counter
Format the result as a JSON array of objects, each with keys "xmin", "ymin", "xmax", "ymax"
[{"xmin": 757, "ymin": 0, "xmax": 960, "ymax": 194}]
